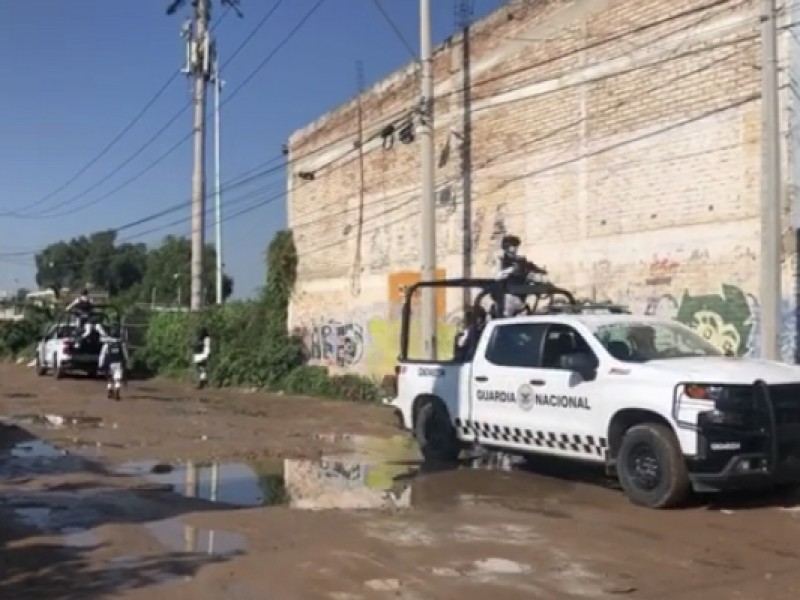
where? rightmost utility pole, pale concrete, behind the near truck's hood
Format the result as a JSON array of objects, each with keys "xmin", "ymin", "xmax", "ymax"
[{"xmin": 759, "ymin": 0, "xmax": 783, "ymax": 360}]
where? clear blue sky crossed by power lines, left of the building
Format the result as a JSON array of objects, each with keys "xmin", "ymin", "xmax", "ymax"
[{"xmin": 0, "ymin": 0, "xmax": 505, "ymax": 297}]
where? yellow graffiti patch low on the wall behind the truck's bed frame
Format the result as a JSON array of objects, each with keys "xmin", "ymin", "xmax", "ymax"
[{"xmin": 364, "ymin": 318, "xmax": 456, "ymax": 378}]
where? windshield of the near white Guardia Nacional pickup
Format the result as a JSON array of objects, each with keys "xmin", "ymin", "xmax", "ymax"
[{"xmin": 594, "ymin": 321, "xmax": 724, "ymax": 362}]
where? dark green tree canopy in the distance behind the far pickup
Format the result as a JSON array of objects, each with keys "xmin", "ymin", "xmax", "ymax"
[{"xmin": 35, "ymin": 230, "xmax": 233, "ymax": 304}]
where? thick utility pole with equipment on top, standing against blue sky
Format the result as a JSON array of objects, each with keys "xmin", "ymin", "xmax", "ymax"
[{"xmin": 174, "ymin": 0, "xmax": 212, "ymax": 310}]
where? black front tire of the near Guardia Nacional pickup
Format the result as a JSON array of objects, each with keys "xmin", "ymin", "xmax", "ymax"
[{"xmin": 617, "ymin": 423, "xmax": 691, "ymax": 509}]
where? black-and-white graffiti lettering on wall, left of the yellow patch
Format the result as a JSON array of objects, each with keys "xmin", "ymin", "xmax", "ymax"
[{"xmin": 302, "ymin": 319, "xmax": 364, "ymax": 367}]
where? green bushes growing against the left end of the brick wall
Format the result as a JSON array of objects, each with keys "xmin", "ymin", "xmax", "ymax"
[{"xmin": 135, "ymin": 231, "xmax": 380, "ymax": 402}]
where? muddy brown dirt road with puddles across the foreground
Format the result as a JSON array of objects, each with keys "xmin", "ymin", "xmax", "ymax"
[{"xmin": 0, "ymin": 366, "xmax": 800, "ymax": 600}]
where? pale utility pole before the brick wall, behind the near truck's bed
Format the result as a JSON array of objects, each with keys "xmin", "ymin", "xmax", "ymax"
[{"xmin": 417, "ymin": 0, "xmax": 437, "ymax": 360}]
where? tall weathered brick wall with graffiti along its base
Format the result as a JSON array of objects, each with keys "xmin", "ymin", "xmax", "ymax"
[{"xmin": 288, "ymin": 0, "xmax": 800, "ymax": 375}]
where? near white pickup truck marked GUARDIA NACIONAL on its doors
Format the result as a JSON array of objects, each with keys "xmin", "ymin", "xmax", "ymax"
[{"xmin": 392, "ymin": 280, "xmax": 800, "ymax": 508}]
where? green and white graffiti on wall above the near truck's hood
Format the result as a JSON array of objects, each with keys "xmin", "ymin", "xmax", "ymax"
[{"xmin": 644, "ymin": 284, "xmax": 797, "ymax": 362}]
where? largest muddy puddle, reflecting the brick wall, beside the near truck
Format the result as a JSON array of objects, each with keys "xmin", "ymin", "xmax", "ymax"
[{"xmin": 114, "ymin": 436, "xmax": 588, "ymax": 518}]
